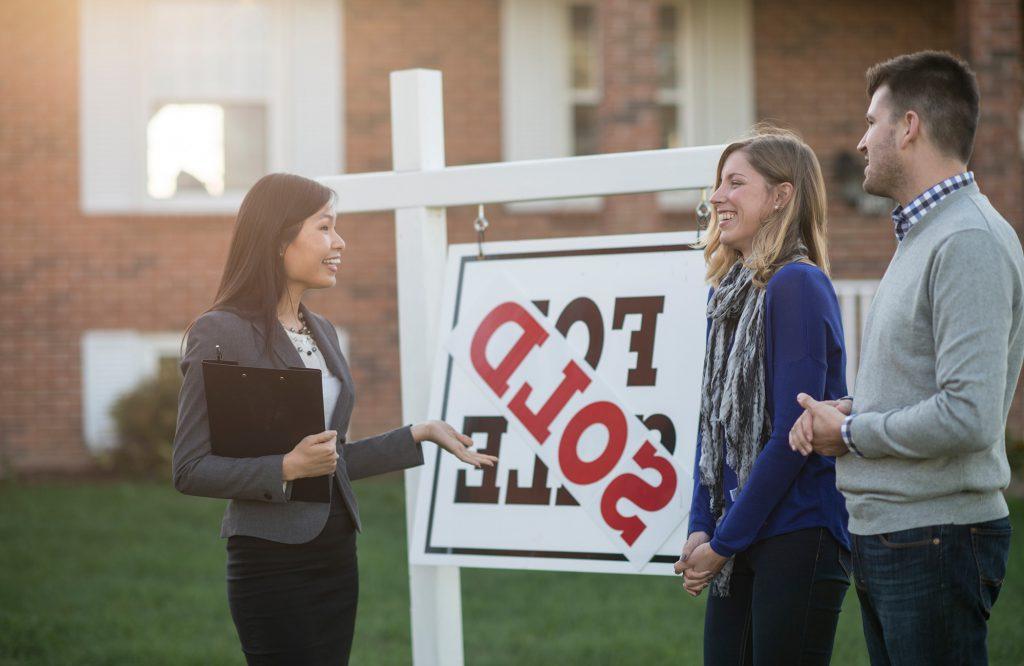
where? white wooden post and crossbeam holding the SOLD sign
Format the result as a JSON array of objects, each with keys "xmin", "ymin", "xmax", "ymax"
[{"xmin": 321, "ymin": 70, "xmax": 723, "ymax": 666}]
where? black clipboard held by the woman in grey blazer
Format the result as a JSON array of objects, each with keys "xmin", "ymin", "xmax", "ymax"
[{"xmin": 203, "ymin": 361, "xmax": 331, "ymax": 502}]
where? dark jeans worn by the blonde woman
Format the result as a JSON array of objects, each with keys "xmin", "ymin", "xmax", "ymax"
[{"xmin": 705, "ymin": 528, "xmax": 850, "ymax": 666}]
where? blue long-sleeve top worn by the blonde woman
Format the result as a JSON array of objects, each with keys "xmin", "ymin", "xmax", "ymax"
[{"xmin": 689, "ymin": 263, "xmax": 850, "ymax": 557}]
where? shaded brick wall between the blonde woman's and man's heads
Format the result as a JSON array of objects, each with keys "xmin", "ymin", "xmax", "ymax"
[{"xmin": 755, "ymin": 0, "xmax": 953, "ymax": 279}]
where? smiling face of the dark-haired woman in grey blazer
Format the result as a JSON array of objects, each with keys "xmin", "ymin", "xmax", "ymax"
[{"xmin": 284, "ymin": 201, "xmax": 345, "ymax": 289}]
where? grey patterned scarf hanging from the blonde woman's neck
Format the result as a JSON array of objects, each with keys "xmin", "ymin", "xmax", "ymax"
[{"xmin": 700, "ymin": 261, "xmax": 771, "ymax": 596}]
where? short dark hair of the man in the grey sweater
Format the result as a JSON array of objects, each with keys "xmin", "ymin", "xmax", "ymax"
[{"xmin": 867, "ymin": 51, "xmax": 978, "ymax": 162}]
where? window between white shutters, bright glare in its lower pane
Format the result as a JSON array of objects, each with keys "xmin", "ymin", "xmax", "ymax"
[{"xmin": 145, "ymin": 0, "xmax": 275, "ymax": 199}]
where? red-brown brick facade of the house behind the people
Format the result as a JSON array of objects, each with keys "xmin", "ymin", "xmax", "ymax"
[{"xmin": 0, "ymin": 0, "xmax": 1024, "ymax": 476}]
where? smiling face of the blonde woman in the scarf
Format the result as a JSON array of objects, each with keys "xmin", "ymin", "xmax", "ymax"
[{"xmin": 711, "ymin": 150, "xmax": 772, "ymax": 257}]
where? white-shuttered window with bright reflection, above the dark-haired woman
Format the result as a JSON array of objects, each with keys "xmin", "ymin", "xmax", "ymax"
[{"xmin": 81, "ymin": 0, "xmax": 342, "ymax": 213}]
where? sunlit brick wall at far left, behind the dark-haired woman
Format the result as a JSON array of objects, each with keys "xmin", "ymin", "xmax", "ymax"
[{"xmin": 0, "ymin": 0, "xmax": 237, "ymax": 470}]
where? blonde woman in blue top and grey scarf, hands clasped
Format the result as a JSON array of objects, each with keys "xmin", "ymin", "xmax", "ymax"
[{"xmin": 676, "ymin": 128, "xmax": 850, "ymax": 665}]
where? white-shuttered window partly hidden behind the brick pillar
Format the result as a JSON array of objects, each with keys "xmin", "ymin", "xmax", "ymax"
[{"xmin": 502, "ymin": 0, "xmax": 754, "ymax": 211}]
